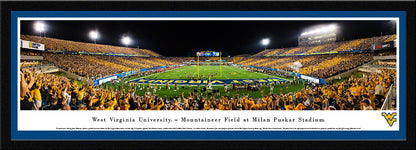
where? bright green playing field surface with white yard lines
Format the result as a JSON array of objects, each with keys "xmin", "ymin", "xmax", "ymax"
[{"xmin": 143, "ymin": 66, "xmax": 288, "ymax": 79}]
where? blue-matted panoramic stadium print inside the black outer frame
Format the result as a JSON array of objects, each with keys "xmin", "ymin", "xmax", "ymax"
[{"xmin": 10, "ymin": 11, "xmax": 407, "ymax": 140}]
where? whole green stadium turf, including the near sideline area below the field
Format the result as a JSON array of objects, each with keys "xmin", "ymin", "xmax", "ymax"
[{"xmin": 103, "ymin": 66, "xmax": 304, "ymax": 98}]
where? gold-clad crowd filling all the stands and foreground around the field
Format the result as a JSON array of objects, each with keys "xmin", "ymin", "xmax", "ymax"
[{"xmin": 19, "ymin": 35, "xmax": 396, "ymax": 110}]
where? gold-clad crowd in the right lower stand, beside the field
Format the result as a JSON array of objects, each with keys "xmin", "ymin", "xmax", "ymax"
[{"xmin": 236, "ymin": 53, "xmax": 373, "ymax": 79}]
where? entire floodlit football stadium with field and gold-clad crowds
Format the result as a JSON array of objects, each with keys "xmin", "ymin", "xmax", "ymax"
[{"xmin": 17, "ymin": 21, "xmax": 398, "ymax": 111}]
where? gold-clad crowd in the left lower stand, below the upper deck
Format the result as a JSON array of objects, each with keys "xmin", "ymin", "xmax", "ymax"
[{"xmin": 43, "ymin": 53, "xmax": 177, "ymax": 79}]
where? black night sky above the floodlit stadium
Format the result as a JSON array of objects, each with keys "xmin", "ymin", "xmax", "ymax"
[{"xmin": 21, "ymin": 21, "xmax": 396, "ymax": 56}]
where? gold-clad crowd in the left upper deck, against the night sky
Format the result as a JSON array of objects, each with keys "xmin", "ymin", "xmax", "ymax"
[{"xmin": 20, "ymin": 35, "xmax": 160, "ymax": 56}]
